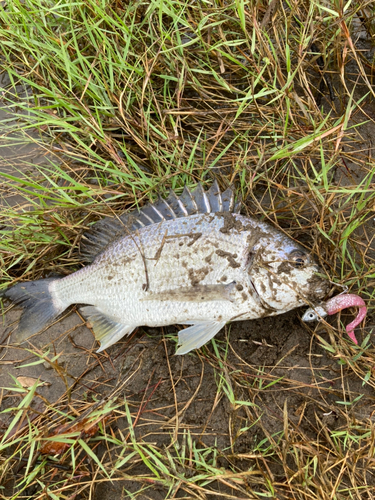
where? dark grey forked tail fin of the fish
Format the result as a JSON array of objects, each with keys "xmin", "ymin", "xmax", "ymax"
[{"xmin": 2, "ymin": 278, "xmax": 66, "ymax": 342}]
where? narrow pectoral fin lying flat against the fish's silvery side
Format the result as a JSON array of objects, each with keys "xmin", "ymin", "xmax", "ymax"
[{"xmin": 141, "ymin": 281, "xmax": 236, "ymax": 302}]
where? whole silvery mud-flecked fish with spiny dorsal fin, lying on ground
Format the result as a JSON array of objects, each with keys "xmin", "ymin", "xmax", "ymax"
[{"xmin": 4, "ymin": 181, "xmax": 329, "ymax": 354}]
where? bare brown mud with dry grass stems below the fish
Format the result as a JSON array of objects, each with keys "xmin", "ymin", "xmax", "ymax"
[{"xmin": 0, "ymin": 298, "xmax": 375, "ymax": 500}]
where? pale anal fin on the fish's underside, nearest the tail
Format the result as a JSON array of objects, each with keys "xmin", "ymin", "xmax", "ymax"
[{"xmin": 80, "ymin": 306, "xmax": 137, "ymax": 352}]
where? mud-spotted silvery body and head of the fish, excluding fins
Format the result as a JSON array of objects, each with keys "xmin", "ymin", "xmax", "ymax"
[{"xmin": 54, "ymin": 213, "xmax": 327, "ymax": 340}]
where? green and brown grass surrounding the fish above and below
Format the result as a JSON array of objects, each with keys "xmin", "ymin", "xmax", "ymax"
[{"xmin": 0, "ymin": 0, "xmax": 375, "ymax": 500}]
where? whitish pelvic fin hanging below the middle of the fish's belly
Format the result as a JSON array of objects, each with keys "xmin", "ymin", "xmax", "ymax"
[{"xmin": 176, "ymin": 321, "xmax": 226, "ymax": 354}]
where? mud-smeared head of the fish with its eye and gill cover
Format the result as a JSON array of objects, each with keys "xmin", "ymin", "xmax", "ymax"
[{"xmin": 249, "ymin": 232, "xmax": 329, "ymax": 314}]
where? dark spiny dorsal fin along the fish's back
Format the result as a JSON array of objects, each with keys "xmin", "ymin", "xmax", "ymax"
[{"xmin": 80, "ymin": 179, "xmax": 241, "ymax": 262}]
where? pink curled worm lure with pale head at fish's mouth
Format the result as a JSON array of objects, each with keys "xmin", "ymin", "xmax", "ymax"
[{"xmin": 302, "ymin": 293, "xmax": 367, "ymax": 344}]
